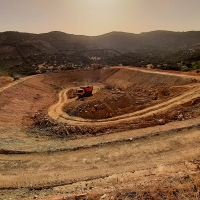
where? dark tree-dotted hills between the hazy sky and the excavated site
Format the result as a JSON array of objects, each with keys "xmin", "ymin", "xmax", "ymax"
[{"xmin": 0, "ymin": 31, "xmax": 200, "ymax": 75}]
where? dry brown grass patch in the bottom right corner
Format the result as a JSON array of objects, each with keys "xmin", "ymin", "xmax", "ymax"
[{"xmin": 86, "ymin": 173, "xmax": 200, "ymax": 200}]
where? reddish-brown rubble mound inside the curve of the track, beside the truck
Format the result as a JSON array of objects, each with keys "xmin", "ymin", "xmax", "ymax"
[{"xmin": 63, "ymin": 85, "xmax": 187, "ymax": 119}]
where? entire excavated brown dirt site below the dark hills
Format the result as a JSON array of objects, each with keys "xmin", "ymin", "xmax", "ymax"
[{"xmin": 0, "ymin": 67, "xmax": 200, "ymax": 200}]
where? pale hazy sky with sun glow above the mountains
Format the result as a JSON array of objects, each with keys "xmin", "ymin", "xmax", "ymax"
[{"xmin": 0, "ymin": 0, "xmax": 200, "ymax": 36}]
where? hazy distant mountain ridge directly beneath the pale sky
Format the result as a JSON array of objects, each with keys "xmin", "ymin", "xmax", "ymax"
[{"xmin": 0, "ymin": 31, "xmax": 200, "ymax": 53}]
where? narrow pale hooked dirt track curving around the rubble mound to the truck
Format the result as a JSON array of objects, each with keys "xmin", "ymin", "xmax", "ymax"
[{"xmin": 48, "ymin": 78, "xmax": 200, "ymax": 126}]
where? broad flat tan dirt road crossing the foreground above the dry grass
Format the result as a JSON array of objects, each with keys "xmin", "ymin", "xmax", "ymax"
[{"xmin": 0, "ymin": 126, "xmax": 200, "ymax": 189}]
